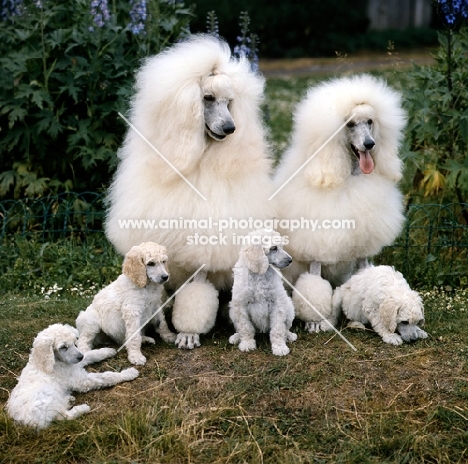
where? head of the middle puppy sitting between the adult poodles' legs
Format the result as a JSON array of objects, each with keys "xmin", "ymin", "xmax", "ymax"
[{"xmin": 241, "ymin": 229, "xmax": 292, "ymax": 274}]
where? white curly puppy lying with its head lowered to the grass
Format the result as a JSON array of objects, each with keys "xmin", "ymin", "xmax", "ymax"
[{"xmin": 333, "ymin": 266, "xmax": 427, "ymax": 345}]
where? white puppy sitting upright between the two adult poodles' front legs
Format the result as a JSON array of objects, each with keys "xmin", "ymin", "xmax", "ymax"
[{"xmin": 229, "ymin": 230, "xmax": 297, "ymax": 356}]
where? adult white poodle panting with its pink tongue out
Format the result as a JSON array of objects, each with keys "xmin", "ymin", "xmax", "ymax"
[{"xmin": 274, "ymin": 75, "xmax": 406, "ymax": 332}]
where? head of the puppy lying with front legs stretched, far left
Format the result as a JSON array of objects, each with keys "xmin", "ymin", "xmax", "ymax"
[{"xmin": 30, "ymin": 324, "xmax": 83, "ymax": 374}]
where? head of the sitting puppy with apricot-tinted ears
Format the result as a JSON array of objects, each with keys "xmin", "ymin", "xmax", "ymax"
[{"xmin": 122, "ymin": 242, "xmax": 169, "ymax": 287}]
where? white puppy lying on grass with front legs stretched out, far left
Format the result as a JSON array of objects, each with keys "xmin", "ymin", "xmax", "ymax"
[{"xmin": 6, "ymin": 324, "xmax": 138, "ymax": 429}]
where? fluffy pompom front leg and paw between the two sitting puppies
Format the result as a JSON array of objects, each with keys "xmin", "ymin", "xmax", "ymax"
[{"xmin": 172, "ymin": 281, "xmax": 219, "ymax": 350}]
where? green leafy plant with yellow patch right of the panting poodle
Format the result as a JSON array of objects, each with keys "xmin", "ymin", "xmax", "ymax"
[{"xmin": 405, "ymin": 27, "xmax": 468, "ymax": 202}]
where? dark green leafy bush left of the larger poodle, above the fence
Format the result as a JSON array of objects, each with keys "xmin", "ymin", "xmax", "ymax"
[{"xmin": 0, "ymin": 0, "xmax": 191, "ymax": 198}]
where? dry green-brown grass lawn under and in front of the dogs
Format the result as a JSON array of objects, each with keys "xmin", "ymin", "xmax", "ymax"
[{"xmin": 0, "ymin": 288, "xmax": 468, "ymax": 463}]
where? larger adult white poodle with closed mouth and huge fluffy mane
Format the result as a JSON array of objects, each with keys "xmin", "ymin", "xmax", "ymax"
[{"xmin": 105, "ymin": 35, "xmax": 275, "ymax": 348}]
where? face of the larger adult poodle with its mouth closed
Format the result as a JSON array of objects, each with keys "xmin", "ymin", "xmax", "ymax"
[{"xmin": 201, "ymin": 73, "xmax": 236, "ymax": 141}]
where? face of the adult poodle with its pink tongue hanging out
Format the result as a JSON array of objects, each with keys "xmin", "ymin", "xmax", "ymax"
[{"xmin": 346, "ymin": 103, "xmax": 376, "ymax": 174}]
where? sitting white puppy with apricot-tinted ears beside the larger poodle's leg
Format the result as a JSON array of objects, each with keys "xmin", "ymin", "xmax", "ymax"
[{"xmin": 76, "ymin": 242, "xmax": 176, "ymax": 365}]
